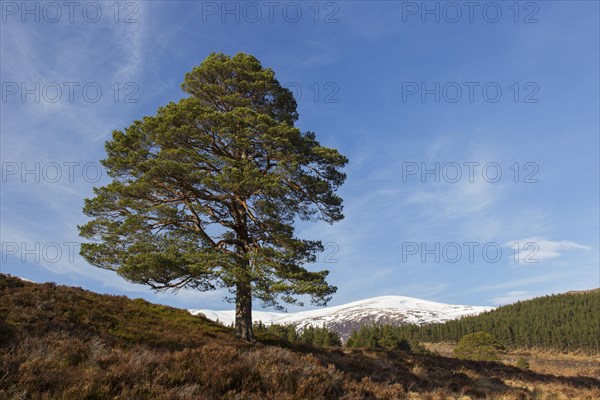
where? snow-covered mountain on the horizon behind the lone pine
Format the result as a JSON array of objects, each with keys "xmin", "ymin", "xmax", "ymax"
[{"xmin": 190, "ymin": 296, "xmax": 493, "ymax": 341}]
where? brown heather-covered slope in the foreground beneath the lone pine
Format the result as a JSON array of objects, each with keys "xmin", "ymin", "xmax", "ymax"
[{"xmin": 0, "ymin": 275, "xmax": 600, "ymax": 400}]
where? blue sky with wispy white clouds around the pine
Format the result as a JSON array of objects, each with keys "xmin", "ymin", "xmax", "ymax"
[{"xmin": 0, "ymin": 1, "xmax": 600, "ymax": 310}]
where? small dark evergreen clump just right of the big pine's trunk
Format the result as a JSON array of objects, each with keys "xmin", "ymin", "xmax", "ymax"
[{"xmin": 253, "ymin": 321, "xmax": 342, "ymax": 347}]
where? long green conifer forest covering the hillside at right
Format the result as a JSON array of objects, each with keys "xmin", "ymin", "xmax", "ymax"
[{"xmin": 347, "ymin": 291, "xmax": 600, "ymax": 354}]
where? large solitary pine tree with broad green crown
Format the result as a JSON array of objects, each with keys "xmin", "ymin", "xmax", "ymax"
[{"xmin": 79, "ymin": 54, "xmax": 348, "ymax": 340}]
